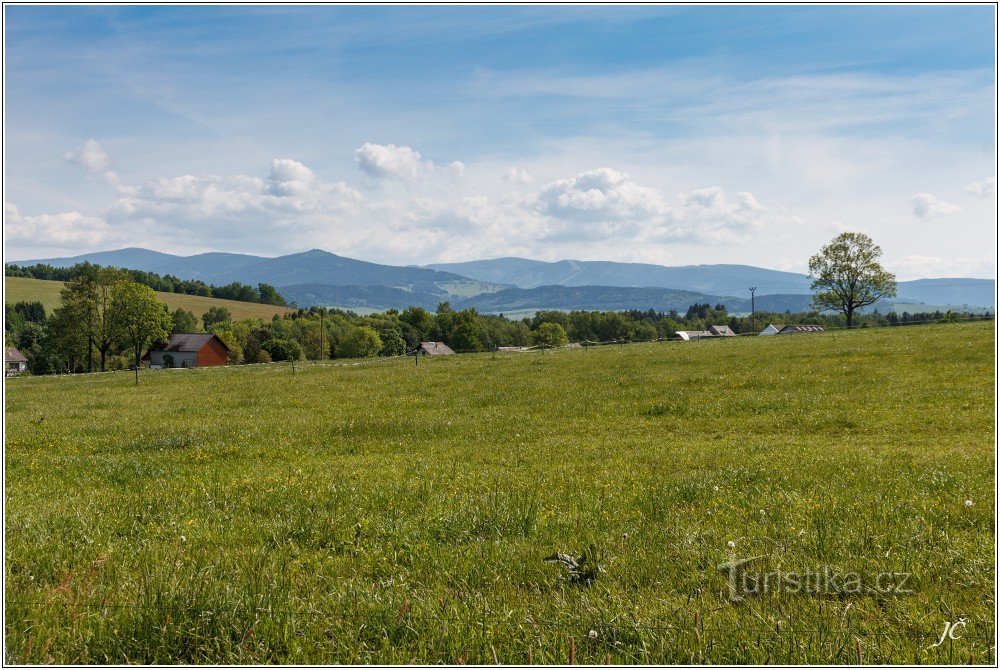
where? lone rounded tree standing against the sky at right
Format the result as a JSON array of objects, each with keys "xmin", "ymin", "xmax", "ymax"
[{"xmin": 809, "ymin": 233, "xmax": 896, "ymax": 328}]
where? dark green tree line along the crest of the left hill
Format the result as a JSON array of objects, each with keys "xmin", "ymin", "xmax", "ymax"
[{"xmin": 4, "ymin": 261, "xmax": 288, "ymax": 307}]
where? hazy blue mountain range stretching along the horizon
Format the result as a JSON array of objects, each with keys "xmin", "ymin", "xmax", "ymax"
[{"xmin": 14, "ymin": 248, "xmax": 995, "ymax": 313}]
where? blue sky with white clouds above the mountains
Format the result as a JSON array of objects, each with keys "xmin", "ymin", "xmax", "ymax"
[{"xmin": 4, "ymin": 5, "xmax": 997, "ymax": 279}]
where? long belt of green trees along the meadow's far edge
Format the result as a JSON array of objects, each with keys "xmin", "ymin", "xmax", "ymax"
[{"xmin": 6, "ymin": 282, "xmax": 992, "ymax": 374}]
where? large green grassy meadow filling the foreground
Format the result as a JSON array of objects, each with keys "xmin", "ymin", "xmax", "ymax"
[{"xmin": 4, "ymin": 323, "xmax": 996, "ymax": 664}]
